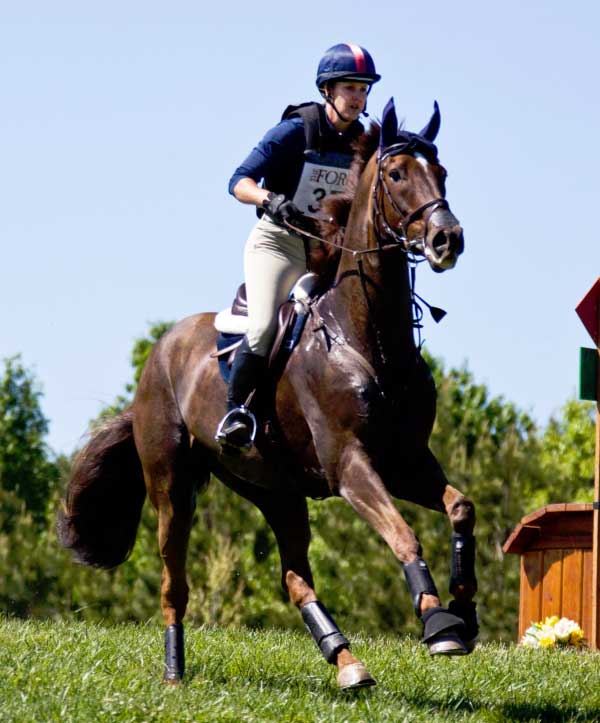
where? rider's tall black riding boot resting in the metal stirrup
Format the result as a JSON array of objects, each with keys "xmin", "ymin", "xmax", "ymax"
[{"xmin": 215, "ymin": 338, "xmax": 267, "ymax": 447}]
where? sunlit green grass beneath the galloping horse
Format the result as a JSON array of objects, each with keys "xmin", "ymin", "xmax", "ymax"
[{"xmin": 0, "ymin": 618, "xmax": 600, "ymax": 723}]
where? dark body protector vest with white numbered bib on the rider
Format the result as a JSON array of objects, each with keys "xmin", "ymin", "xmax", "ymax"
[{"xmin": 282, "ymin": 103, "xmax": 364, "ymax": 218}]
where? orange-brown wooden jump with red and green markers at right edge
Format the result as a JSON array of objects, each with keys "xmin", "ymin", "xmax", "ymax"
[{"xmin": 502, "ymin": 278, "xmax": 600, "ymax": 650}]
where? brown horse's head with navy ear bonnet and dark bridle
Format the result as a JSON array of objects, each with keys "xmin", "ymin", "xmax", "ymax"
[{"xmin": 373, "ymin": 98, "xmax": 464, "ymax": 272}]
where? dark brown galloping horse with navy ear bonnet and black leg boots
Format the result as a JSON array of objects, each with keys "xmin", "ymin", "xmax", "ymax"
[{"xmin": 57, "ymin": 99, "xmax": 478, "ymax": 689}]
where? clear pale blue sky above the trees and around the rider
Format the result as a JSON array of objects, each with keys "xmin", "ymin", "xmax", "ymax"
[{"xmin": 0, "ymin": 0, "xmax": 600, "ymax": 452}]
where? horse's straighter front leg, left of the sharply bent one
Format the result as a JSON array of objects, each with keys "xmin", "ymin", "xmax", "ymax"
[{"xmin": 337, "ymin": 441, "xmax": 469, "ymax": 655}]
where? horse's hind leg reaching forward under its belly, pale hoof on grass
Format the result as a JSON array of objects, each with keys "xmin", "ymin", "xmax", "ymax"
[{"xmin": 253, "ymin": 495, "xmax": 375, "ymax": 690}]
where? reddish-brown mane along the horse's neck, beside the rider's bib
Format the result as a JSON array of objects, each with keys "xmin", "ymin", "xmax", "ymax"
[{"xmin": 309, "ymin": 122, "xmax": 381, "ymax": 288}]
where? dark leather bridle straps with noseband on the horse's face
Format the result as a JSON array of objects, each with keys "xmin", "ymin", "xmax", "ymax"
[{"xmin": 373, "ymin": 143, "xmax": 450, "ymax": 253}]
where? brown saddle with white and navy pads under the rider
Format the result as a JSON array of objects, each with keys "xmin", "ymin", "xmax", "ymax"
[{"xmin": 210, "ymin": 272, "xmax": 319, "ymax": 383}]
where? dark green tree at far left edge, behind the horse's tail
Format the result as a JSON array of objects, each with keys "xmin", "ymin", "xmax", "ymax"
[{"xmin": 0, "ymin": 355, "xmax": 58, "ymax": 526}]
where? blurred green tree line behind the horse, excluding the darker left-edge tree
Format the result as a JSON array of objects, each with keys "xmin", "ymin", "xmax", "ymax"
[{"xmin": 37, "ymin": 323, "xmax": 594, "ymax": 640}]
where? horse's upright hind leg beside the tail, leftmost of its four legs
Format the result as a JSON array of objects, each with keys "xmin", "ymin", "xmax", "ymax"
[{"xmin": 134, "ymin": 420, "xmax": 208, "ymax": 683}]
